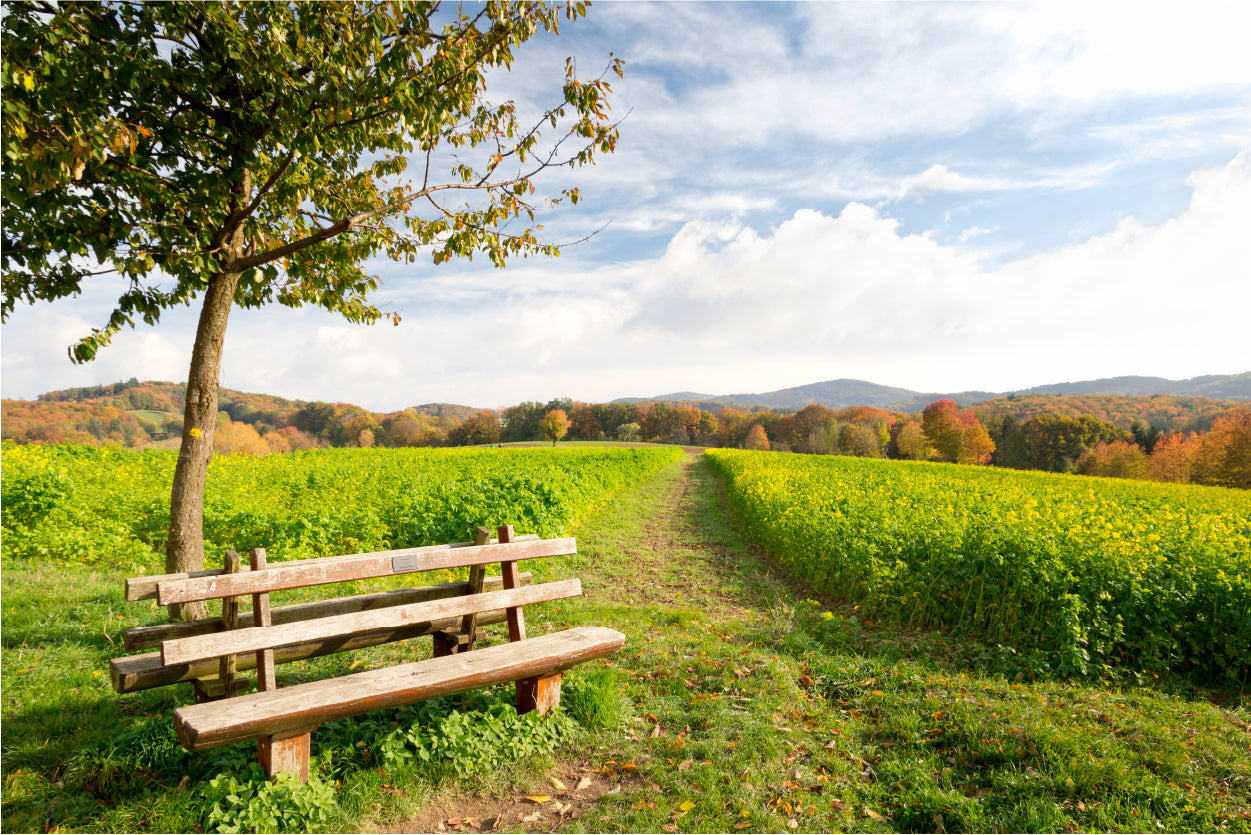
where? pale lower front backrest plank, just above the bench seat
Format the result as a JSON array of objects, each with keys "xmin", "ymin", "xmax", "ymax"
[{"xmin": 161, "ymin": 580, "xmax": 582, "ymax": 665}]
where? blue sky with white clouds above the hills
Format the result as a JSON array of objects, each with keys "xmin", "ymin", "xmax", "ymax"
[{"xmin": 0, "ymin": 1, "xmax": 1251, "ymax": 411}]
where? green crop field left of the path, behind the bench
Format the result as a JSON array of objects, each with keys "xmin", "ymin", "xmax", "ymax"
[{"xmin": 3, "ymin": 444, "xmax": 682, "ymax": 572}]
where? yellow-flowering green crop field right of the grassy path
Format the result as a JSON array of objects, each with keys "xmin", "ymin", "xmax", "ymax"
[{"xmin": 708, "ymin": 449, "xmax": 1251, "ymax": 685}]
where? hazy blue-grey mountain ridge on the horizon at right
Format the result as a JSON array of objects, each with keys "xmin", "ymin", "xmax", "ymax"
[{"xmin": 615, "ymin": 372, "xmax": 1251, "ymax": 412}]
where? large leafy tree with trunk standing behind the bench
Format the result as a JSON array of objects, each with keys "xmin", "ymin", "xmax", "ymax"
[{"xmin": 0, "ymin": 0, "xmax": 620, "ymax": 616}]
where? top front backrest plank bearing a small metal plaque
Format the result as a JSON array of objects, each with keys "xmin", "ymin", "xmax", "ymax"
[{"xmin": 156, "ymin": 537, "xmax": 578, "ymax": 606}]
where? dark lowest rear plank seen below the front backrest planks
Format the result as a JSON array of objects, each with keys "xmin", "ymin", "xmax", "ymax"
[{"xmin": 109, "ymin": 608, "xmax": 517, "ymax": 694}]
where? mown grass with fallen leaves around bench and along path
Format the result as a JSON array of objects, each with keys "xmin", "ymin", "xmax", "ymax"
[{"xmin": 0, "ymin": 456, "xmax": 1251, "ymax": 832}]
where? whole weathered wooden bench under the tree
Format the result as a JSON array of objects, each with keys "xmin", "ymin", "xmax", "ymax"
[{"xmin": 110, "ymin": 526, "xmax": 626, "ymax": 782}]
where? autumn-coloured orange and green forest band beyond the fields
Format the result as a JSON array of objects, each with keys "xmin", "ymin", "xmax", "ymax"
[{"xmin": 3, "ymin": 379, "xmax": 1251, "ymax": 488}]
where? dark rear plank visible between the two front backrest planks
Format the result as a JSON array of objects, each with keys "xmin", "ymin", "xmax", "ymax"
[{"xmin": 121, "ymin": 575, "xmax": 533, "ymax": 652}]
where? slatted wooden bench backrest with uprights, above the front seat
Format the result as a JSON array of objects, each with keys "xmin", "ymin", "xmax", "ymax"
[{"xmin": 110, "ymin": 526, "xmax": 582, "ymax": 692}]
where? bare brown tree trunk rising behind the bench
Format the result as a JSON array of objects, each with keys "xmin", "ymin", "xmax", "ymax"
[{"xmin": 165, "ymin": 267, "xmax": 239, "ymax": 621}]
